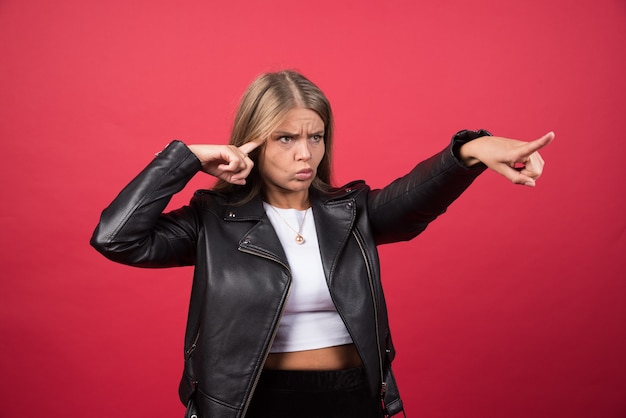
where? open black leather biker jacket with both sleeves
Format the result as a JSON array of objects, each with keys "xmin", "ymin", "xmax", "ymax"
[{"xmin": 91, "ymin": 131, "xmax": 488, "ymax": 418}]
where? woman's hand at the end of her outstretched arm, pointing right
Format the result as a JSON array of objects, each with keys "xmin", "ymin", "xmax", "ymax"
[{"xmin": 459, "ymin": 132, "xmax": 554, "ymax": 187}]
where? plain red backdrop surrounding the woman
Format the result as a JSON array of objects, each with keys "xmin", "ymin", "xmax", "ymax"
[{"xmin": 0, "ymin": 0, "xmax": 626, "ymax": 418}]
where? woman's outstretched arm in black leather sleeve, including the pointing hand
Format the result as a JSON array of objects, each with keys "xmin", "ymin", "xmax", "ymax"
[{"xmin": 369, "ymin": 131, "xmax": 554, "ymax": 244}]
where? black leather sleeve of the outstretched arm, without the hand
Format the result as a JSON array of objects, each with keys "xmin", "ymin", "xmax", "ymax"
[{"xmin": 368, "ymin": 130, "xmax": 491, "ymax": 244}]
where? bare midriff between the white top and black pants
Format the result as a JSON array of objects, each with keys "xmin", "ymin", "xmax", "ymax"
[{"xmin": 265, "ymin": 344, "xmax": 362, "ymax": 370}]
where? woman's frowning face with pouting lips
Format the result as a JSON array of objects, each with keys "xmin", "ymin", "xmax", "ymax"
[{"xmin": 258, "ymin": 108, "xmax": 325, "ymax": 203}]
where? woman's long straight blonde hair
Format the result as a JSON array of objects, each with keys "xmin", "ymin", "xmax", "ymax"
[{"xmin": 213, "ymin": 70, "xmax": 333, "ymax": 204}]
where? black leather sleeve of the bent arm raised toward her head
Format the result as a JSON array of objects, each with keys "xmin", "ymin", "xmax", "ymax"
[{"xmin": 90, "ymin": 141, "xmax": 201, "ymax": 267}]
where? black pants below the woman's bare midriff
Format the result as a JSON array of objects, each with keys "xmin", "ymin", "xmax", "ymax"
[{"xmin": 246, "ymin": 368, "xmax": 383, "ymax": 418}]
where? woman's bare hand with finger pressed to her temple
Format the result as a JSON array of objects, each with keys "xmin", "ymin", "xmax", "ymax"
[{"xmin": 188, "ymin": 140, "xmax": 264, "ymax": 185}]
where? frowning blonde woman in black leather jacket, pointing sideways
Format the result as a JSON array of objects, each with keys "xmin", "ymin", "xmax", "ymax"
[{"xmin": 91, "ymin": 71, "xmax": 554, "ymax": 418}]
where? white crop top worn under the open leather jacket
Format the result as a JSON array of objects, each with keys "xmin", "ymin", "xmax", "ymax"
[{"xmin": 263, "ymin": 203, "xmax": 352, "ymax": 353}]
